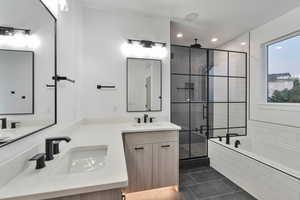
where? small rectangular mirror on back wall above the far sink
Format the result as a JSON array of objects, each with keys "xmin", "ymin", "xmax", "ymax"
[{"xmin": 127, "ymin": 58, "xmax": 162, "ymax": 112}]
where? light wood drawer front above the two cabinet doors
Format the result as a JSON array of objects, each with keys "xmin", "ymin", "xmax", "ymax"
[{"xmin": 125, "ymin": 131, "xmax": 178, "ymax": 145}]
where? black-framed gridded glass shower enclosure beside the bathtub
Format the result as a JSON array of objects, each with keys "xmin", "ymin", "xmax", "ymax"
[{"xmin": 171, "ymin": 45, "xmax": 247, "ymax": 159}]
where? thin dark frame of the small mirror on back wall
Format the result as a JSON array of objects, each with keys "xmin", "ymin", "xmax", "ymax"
[{"xmin": 126, "ymin": 57, "xmax": 163, "ymax": 113}]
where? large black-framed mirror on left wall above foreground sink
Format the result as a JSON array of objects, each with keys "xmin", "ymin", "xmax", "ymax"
[{"xmin": 0, "ymin": 0, "xmax": 57, "ymax": 147}]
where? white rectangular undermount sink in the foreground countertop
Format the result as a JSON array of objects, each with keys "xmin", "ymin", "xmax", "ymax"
[{"xmin": 61, "ymin": 145, "xmax": 108, "ymax": 173}]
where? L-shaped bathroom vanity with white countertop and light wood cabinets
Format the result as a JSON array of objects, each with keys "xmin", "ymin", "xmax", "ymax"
[{"xmin": 0, "ymin": 122, "xmax": 180, "ymax": 200}]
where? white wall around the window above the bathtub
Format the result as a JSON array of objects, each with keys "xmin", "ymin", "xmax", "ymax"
[{"xmin": 249, "ymin": 7, "xmax": 300, "ymax": 164}]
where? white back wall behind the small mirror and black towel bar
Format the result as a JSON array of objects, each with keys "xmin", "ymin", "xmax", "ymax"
[{"xmin": 79, "ymin": 8, "xmax": 170, "ymax": 119}]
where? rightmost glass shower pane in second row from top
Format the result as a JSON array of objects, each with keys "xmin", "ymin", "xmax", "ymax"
[{"xmin": 229, "ymin": 78, "xmax": 247, "ymax": 102}]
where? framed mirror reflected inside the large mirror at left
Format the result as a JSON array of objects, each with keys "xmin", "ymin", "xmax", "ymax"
[{"xmin": 0, "ymin": 49, "xmax": 34, "ymax": 115}]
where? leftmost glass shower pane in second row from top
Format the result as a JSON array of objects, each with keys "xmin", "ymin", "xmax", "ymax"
[{"xmin": 171, "ymin": 75, "xmax": 190, "ymax": 102}]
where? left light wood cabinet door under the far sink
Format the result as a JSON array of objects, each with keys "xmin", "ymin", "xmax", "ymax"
[{"xmin": 126, "ymin": 144, "xmax": 153, "ymax": 192}]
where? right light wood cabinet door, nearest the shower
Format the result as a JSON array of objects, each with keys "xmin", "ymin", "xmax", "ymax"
[{"xmin": 153, "ymin": 142, "xmax": 179, "ymax": 188}]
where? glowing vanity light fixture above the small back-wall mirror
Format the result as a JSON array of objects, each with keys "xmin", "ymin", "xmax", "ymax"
[{"xmin": 121, "ymin": 39, "xmax": 168, "ymax": 58}]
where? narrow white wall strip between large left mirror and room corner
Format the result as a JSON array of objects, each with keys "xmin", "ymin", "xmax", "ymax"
[{"xmin": 57, "ymin": 1, "xmax": 83, "ymax": 124}]
